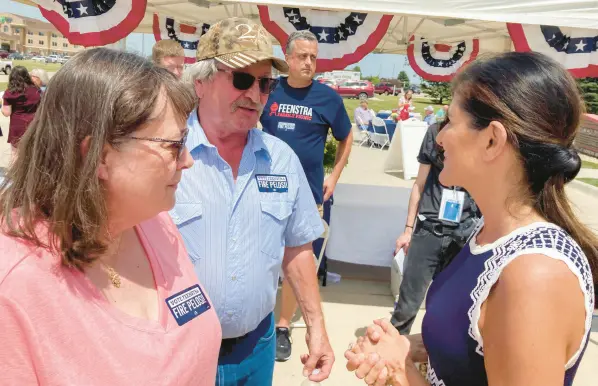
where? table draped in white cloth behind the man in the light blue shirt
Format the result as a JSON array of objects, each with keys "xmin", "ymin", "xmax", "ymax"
[{"xmin": 326, "ymin": 184, "xmax": 411, "ymax": 267}]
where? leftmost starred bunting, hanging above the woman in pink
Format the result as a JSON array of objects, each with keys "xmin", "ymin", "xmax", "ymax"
[{"xmin": 32, "ymin": 0, "xmax": 147, "ymax": 47}]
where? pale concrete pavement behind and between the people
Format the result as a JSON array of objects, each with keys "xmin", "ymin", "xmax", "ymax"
[{"xmin": 0, "ymin": 116, "xmax": 598, "ymax": 386}]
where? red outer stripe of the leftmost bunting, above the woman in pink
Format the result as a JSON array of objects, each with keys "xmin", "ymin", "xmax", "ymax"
[{"xmin": 37, "ymin": 0, "xmax": 147, "ymax": 47}]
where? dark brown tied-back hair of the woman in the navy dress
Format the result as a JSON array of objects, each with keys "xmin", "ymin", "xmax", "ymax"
[{"xmin": 453, "ymin": 52, "xmax": 598, "ymax": 280}]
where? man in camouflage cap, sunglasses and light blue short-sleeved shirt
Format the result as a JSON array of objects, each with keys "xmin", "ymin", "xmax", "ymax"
[{"xmin": 171, "ymin": 18, "xmax": 334, "ymax": 386}]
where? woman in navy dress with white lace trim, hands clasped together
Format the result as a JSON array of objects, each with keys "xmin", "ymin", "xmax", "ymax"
[{"xmin": 345, "ymin": 53, "xmax": 598, "ymax": 386}]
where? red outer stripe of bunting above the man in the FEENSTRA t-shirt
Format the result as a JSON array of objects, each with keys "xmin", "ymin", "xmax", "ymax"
[{"xmin": 257, "ymin": 5, "xmax": 392, "ymax": 72}]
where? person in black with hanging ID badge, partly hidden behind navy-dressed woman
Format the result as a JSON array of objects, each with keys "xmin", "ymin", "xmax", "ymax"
[{"xmin": 391, "ymin": 123, "xmax": 480, "ymax": 335}]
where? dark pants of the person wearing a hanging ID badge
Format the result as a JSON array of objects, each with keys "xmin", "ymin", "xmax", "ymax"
[{"xmin": 390, "ymin": 222, "xmax": 461, "ymax": 335}]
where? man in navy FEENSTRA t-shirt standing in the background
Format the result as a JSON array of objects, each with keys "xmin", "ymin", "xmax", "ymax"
[{"xmin": 260, "ymin": 31, "xmax": 353, "ymax": 361}]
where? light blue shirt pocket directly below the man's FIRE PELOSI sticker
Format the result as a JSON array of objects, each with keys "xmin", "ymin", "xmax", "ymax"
[{"xmin": 260, "ymin": 200, "xmax": 293, "ymax": 259}]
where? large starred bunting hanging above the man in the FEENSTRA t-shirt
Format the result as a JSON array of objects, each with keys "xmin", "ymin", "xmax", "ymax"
[{"xmin": 258, "ymin": 5, "xmax": 392, "ymax": 72}]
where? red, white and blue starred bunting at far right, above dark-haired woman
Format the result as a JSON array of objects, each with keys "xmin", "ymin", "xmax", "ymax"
[{"xmin": 507, "ymin": 23, "xmax": 598, "ymax": 78}]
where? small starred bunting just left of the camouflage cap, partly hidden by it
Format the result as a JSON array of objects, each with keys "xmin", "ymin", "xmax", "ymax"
[{"xmin": 153, "ymin": 13, "xmax": 210, "ymax": 64}]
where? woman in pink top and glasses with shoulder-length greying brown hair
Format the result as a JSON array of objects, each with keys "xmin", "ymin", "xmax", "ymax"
[{"xmin": 0, "ymin": 48, "xmax": 221, "ymax": 386}]
